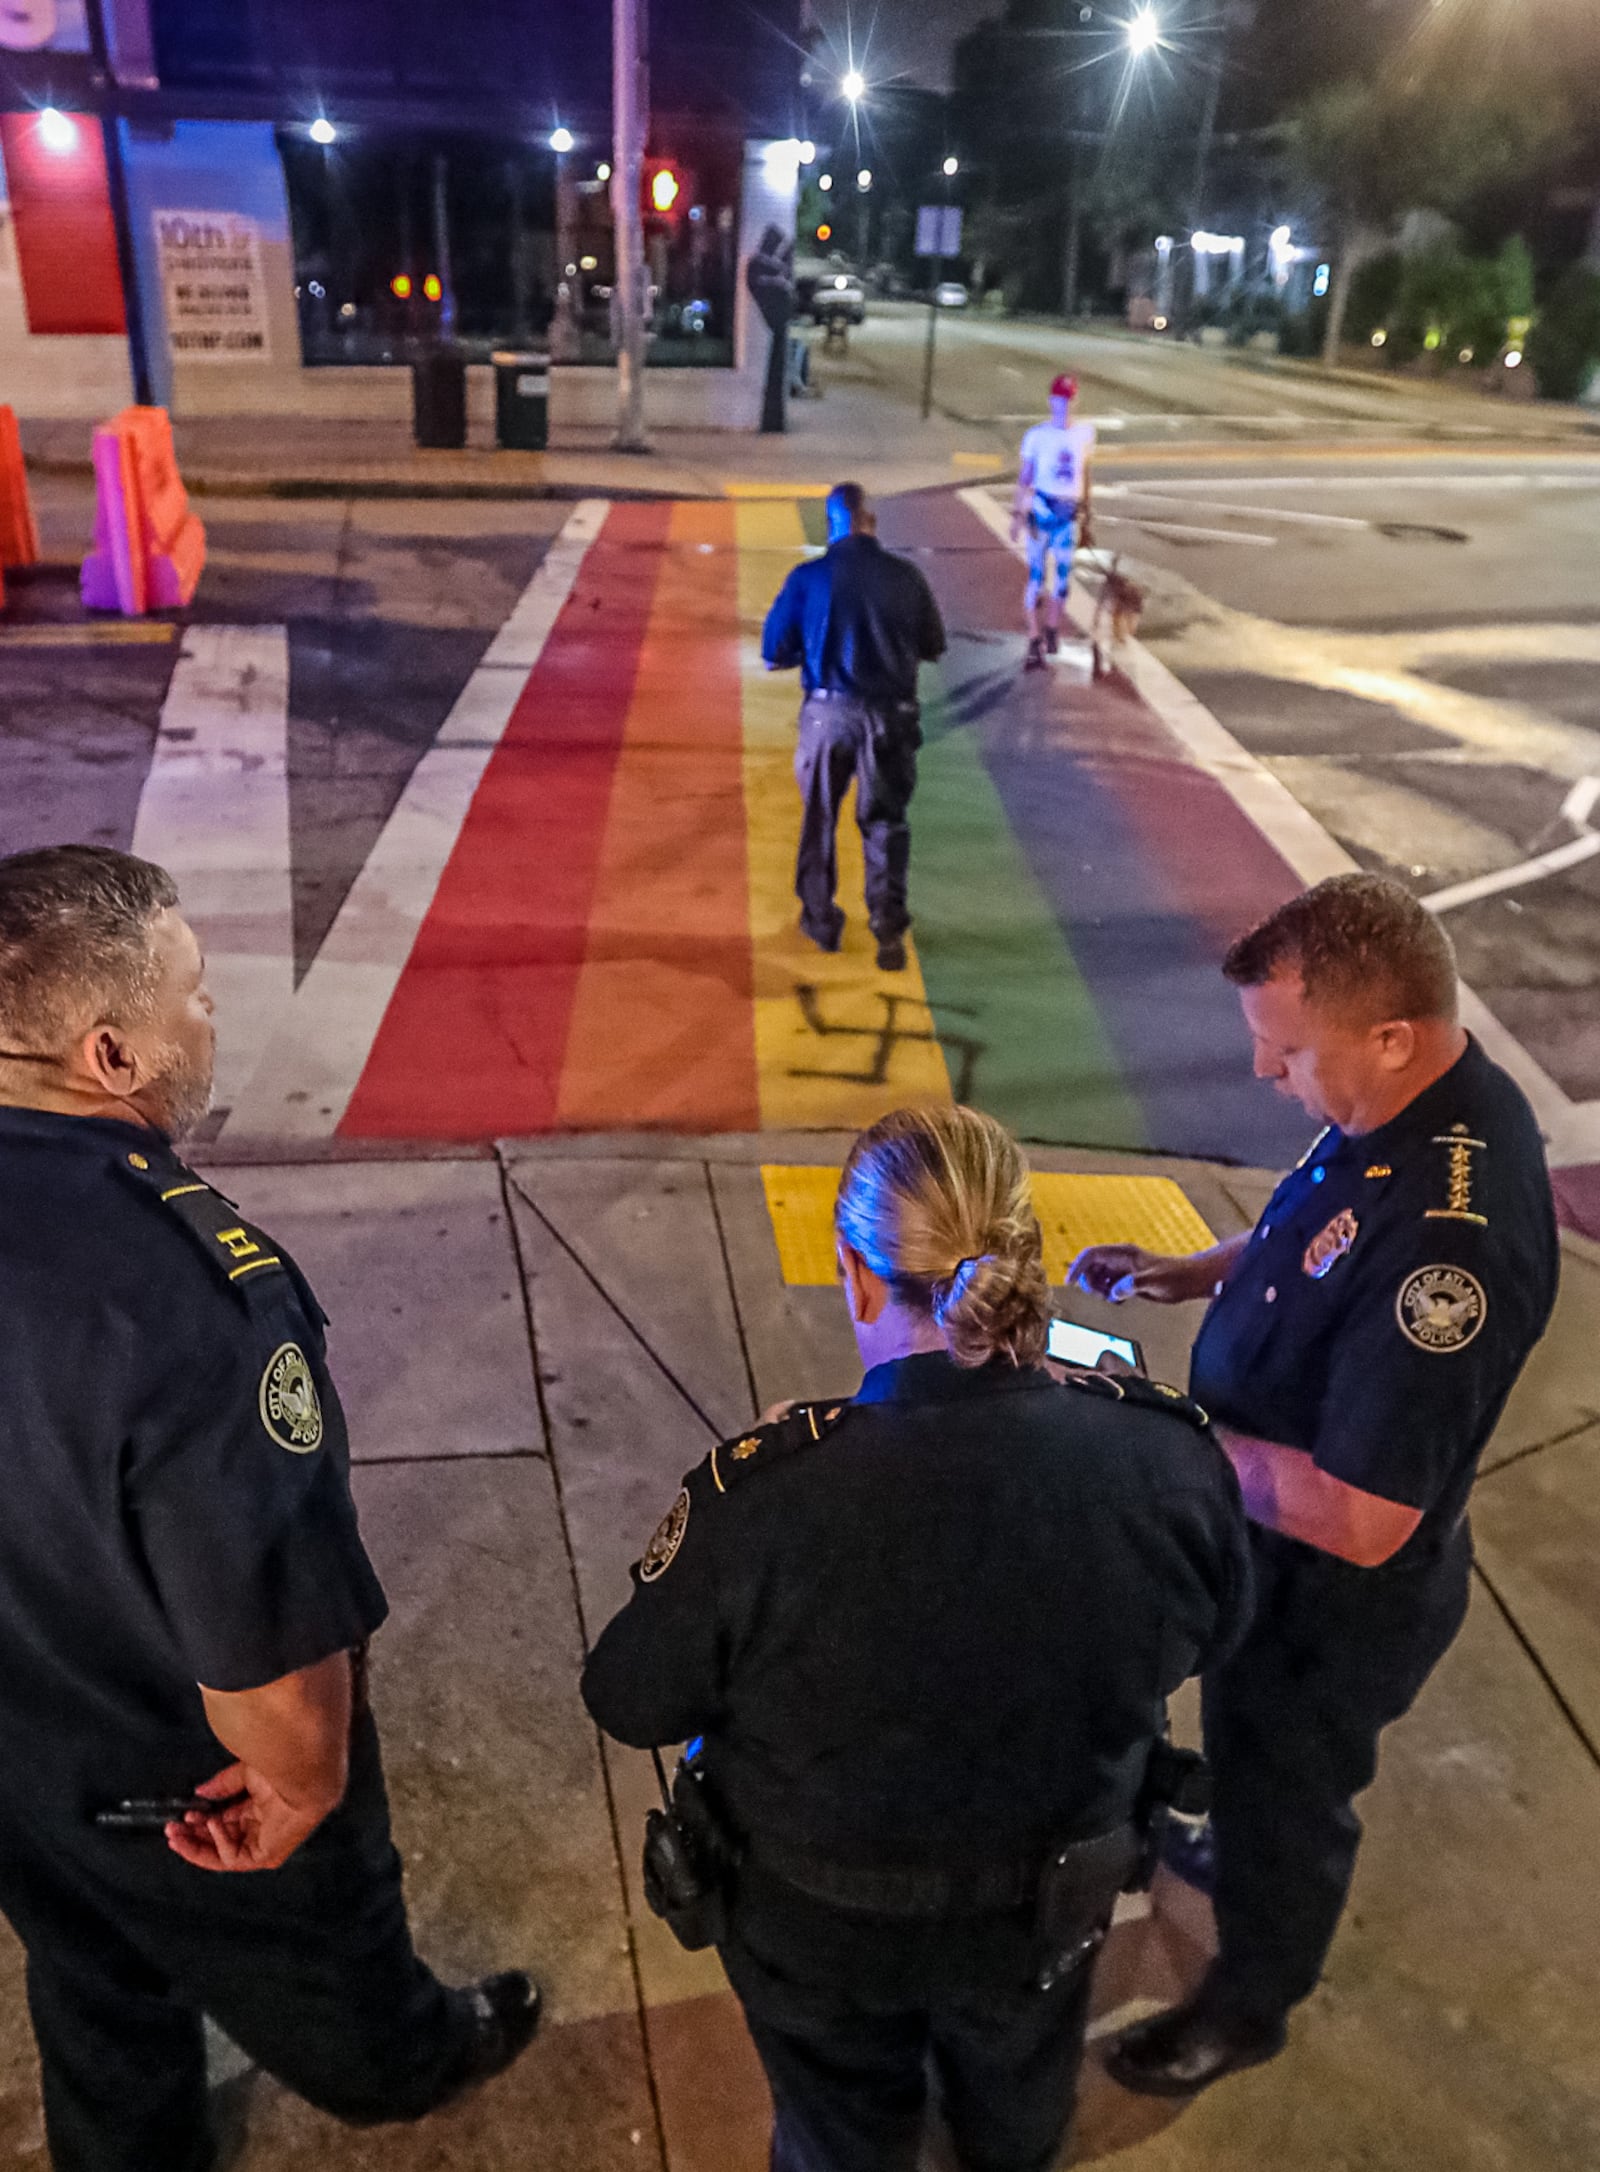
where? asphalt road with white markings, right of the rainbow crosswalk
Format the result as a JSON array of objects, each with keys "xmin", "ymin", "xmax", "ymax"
[{"xmin": 860, "ymin": 311, "xmax": 1600, "ymax": 1119}]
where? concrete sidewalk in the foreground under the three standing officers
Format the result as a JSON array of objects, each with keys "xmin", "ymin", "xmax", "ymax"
[{"xmin": 0, "ymin": 1134, "xmax": 1600, "ymax": 2172}]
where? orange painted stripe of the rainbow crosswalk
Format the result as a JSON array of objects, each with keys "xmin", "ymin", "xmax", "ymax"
[{"xmin": 556, "ymin": 502, "xmax": 760, "ymax": 1132}]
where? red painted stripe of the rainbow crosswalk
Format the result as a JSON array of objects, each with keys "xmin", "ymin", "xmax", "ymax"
[{"xmin": 339, "ymin": 504, "xmax": 671, "ymax": 1138}]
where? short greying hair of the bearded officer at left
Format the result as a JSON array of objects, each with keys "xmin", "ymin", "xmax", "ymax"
[{"xmin": 0, "ymin": 845, "xmax": 178, "ymax": 1053}]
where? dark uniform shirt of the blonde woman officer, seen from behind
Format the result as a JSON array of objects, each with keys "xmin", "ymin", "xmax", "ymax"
[{"xmin": 584, "ymin": 1353, "xmax": 1248, "ymax": 1868}]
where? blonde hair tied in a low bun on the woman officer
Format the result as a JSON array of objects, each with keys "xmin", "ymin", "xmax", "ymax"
[{"xmin": 834, "ymin": 1108, "xmax": 1051, "ymax": 1366}]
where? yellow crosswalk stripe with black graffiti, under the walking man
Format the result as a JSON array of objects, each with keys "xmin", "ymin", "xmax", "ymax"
[{"xmin": 736, "ymin": 500, "xmax": 951, "ymax": 1132}]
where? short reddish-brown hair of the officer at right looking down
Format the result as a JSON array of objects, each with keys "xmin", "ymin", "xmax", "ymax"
[{"xmin": 1222, "ymin": 875, "xmax": 1457, "ymax": 1025}]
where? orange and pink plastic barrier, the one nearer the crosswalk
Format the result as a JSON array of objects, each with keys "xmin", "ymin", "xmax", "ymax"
[{"xmin": 82, "ymin": 408, "xmax": 206, "ymax": 619}]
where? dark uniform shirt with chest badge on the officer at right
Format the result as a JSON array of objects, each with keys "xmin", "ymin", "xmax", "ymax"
[{"xmin": 1190, "ymin": 1040, "xmax": 1559, "ymax": 1559}]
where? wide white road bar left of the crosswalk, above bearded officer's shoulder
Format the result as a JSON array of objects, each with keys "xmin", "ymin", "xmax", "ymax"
[{"xmin": 132, "ymin": 626, "xmax": 295, "ymax": 1108}]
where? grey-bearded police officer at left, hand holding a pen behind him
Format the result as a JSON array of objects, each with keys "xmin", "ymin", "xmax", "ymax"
[{"xmin": 0, "ymin": 845, "xmax": 538, "ymax": 2172}]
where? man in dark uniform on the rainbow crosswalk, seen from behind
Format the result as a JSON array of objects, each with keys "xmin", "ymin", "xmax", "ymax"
[{"xmin": 762, "ymin": 482, "xmax": 944, "ymax": 973}]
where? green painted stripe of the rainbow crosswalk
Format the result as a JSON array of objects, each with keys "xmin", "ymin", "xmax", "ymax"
[{"xmin": 912, "ymin": 673, "xmax": 1146, "ymax": 1147}]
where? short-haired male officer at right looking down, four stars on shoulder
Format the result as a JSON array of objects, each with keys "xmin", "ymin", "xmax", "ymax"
[{"xmin": 1072, "ymin": 875, "xmax": 1559, "ymax": 2094}]
